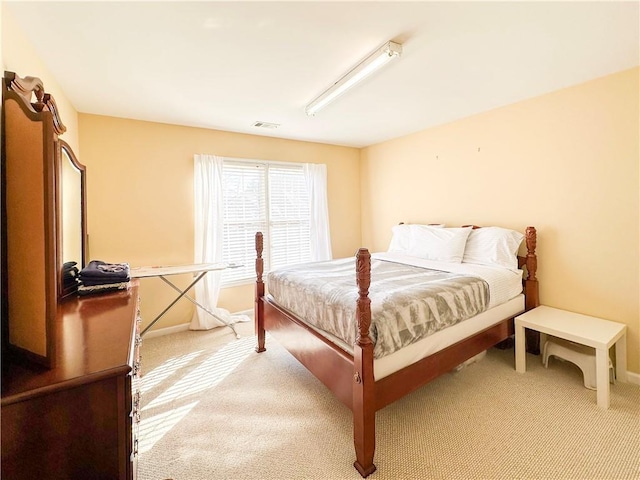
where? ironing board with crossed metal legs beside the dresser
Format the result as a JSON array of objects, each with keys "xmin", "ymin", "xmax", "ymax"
[{"xmin": 129, "ymin": 263, "xmax": 241, "ymax": 338}]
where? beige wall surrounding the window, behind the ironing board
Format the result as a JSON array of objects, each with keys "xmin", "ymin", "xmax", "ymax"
[{"xmin": 79, "ymin": 114, "xmax": 361, "ymax": 328}]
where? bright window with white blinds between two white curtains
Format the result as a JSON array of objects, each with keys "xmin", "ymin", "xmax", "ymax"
[{"xmin": 222, "ymin": 159, "xmax": 311, "ymax": 286}]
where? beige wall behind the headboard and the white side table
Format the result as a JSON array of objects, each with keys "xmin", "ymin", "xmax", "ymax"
[{"xmin": 361, "ymin": 68, "xmax": 640, "ymax": 373}]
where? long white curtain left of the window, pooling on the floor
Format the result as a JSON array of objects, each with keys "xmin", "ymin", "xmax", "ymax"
[{"xmin": 189, "ymin": 155, "xmax": 248, "ymax": 330}]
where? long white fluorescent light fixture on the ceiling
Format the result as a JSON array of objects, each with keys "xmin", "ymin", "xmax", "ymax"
[{"xmin": 304, "ymin": 42, "xmax": 402, "ymax": 116}]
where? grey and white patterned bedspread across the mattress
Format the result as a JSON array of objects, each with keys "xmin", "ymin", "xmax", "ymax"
[{"xmin": 267, "ymin": 258, "xmax": 489, "ymax": 358}]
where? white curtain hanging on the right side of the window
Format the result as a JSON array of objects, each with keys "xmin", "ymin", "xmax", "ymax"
[{"xmin": 304, "ymin": 163, "xmax": 333, "ymax": 262}]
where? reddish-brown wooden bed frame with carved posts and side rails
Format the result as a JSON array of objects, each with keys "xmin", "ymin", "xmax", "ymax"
[{"xmin": 255, "ymin": 227, "xmax": 539, "ymax": 477}]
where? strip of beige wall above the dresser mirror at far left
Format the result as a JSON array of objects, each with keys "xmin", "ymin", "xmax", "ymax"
[{"xmin": 0, "ymin": 7, "xmax": 80, "ymax": 154}]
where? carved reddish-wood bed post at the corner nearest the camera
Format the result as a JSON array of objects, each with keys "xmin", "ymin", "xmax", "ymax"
[{"xmin": 352, "ymin": 248, "xmax": 376, "ymax": 477}]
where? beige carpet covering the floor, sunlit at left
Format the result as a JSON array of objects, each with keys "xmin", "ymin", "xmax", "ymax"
[{"xmin": 138, "ymin": 324, "xmax": 640, "ymax": 480}]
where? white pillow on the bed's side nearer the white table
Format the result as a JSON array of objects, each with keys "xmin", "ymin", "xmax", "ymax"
[{"xmin": 462, "ymin": 227, "xmax": 524, "ymax": 271}]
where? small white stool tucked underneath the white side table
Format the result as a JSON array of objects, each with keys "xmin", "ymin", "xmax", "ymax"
[{"xmin": 542, "ymin": 337, "xmax": 615, "ymax": 390}]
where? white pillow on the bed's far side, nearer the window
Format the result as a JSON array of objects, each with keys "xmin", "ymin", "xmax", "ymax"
[{"xmin": 408, "ymin": 225, "xmax": 471, "ymax": 263}]
